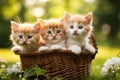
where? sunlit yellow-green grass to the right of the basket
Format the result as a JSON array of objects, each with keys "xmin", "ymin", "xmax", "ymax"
[{"xmin": 92, "ymin": 46, "xmax": 120, "ymax": 77}]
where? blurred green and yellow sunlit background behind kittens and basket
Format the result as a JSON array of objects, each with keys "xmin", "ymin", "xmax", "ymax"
[{"xmin": 0, "ymin": 0, "xmax": 120, "ymax": 77}]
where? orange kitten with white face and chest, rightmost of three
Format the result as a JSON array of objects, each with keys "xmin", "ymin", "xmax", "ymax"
[{"xmin": 62, "ymin": 13, "xmax": 95, "ymax": 54}]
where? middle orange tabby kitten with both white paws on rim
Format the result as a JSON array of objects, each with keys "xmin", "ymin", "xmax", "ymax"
[{"xmin": 39, "ymin": 19, "xmax": 66, "ymax": 51}]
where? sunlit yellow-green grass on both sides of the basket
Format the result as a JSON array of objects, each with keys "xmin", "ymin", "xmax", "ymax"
[{"xmin": 0, "ymin": 46, "xmax": 120, "ymax": 77}]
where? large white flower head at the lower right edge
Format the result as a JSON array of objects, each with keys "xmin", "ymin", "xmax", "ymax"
[{"xmin": 101, "ymin": 57, "xmax": 120, "ymax": 76}]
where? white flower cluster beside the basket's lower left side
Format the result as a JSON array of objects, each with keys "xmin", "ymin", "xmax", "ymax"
[{"xmin": 7, "ymin": 62, "xmax": 22, "ymax": 75}]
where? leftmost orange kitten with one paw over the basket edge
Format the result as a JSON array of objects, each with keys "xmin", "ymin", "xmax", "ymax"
[{"xmin": 10, "ymin": 21, "xmax": 40, "ymax": 52}]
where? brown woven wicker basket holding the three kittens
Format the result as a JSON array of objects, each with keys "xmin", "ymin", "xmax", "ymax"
[{"xmin": 16, "ymin": 35, "xmax": 97, "ymax": 80}]
